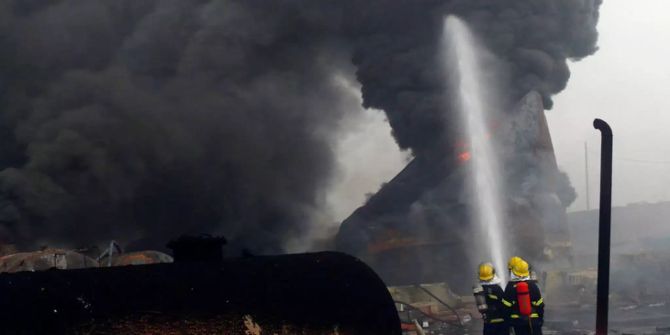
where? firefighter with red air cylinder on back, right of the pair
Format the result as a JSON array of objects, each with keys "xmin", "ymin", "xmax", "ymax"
[{"xmin": 502, "ymin": 260, "xmax": 544, "ymax": 335}]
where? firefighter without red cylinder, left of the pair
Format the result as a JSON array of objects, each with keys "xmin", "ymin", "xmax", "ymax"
[{"xmin": 473, "ymin": 263, "xmax": 509, "ymax": 335}]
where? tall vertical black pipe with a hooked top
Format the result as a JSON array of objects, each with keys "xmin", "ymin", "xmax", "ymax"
[{"xmin": 593, "ymin": 119, "xmax": 612, "ymax": 335}]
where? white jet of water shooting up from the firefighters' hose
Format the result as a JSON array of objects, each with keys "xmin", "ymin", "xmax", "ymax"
[{"xmin": 442, "ymin": 15, "xmax": 506, "ymax": 280}]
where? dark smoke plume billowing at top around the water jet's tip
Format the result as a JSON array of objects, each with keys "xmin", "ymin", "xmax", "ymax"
[{"xmin": 353, "ymin": 0, "xmax": 602, "ymax": 154}]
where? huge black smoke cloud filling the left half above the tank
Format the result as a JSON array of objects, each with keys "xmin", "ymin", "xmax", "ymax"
[{"xmin": 0, "ymin": 0, "xmax": 357, "ymax": 251}]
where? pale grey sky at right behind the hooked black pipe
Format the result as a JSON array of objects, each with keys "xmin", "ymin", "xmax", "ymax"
[{"xmin": 547, "ymin": 0, "xmax": 670, "ymax": 210}]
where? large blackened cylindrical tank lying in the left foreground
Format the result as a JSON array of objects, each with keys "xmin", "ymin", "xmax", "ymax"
[{"xmin": 0, "ymin": 252, "xmax": 400, "ymax": 335}]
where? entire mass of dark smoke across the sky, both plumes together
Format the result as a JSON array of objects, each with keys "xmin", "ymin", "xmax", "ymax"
[{"xmin": 0, "ymin": 0, "xmax": 600, "ymax": 255}]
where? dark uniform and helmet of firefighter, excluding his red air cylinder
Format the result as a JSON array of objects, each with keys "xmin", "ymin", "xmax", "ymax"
[{"xmin": 502, "ymin": 262, "xmax": 544, "ymax": 335}]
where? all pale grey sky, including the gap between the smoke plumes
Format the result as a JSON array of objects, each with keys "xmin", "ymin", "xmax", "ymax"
[{"xmin": 327, "ymin": 0, "xmax": 670, "ymax": 226}]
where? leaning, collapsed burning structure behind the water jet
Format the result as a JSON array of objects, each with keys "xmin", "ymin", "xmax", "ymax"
[{"xmin": 338, "ymin": 92, "xmax": 574, "ymax": 292}]
